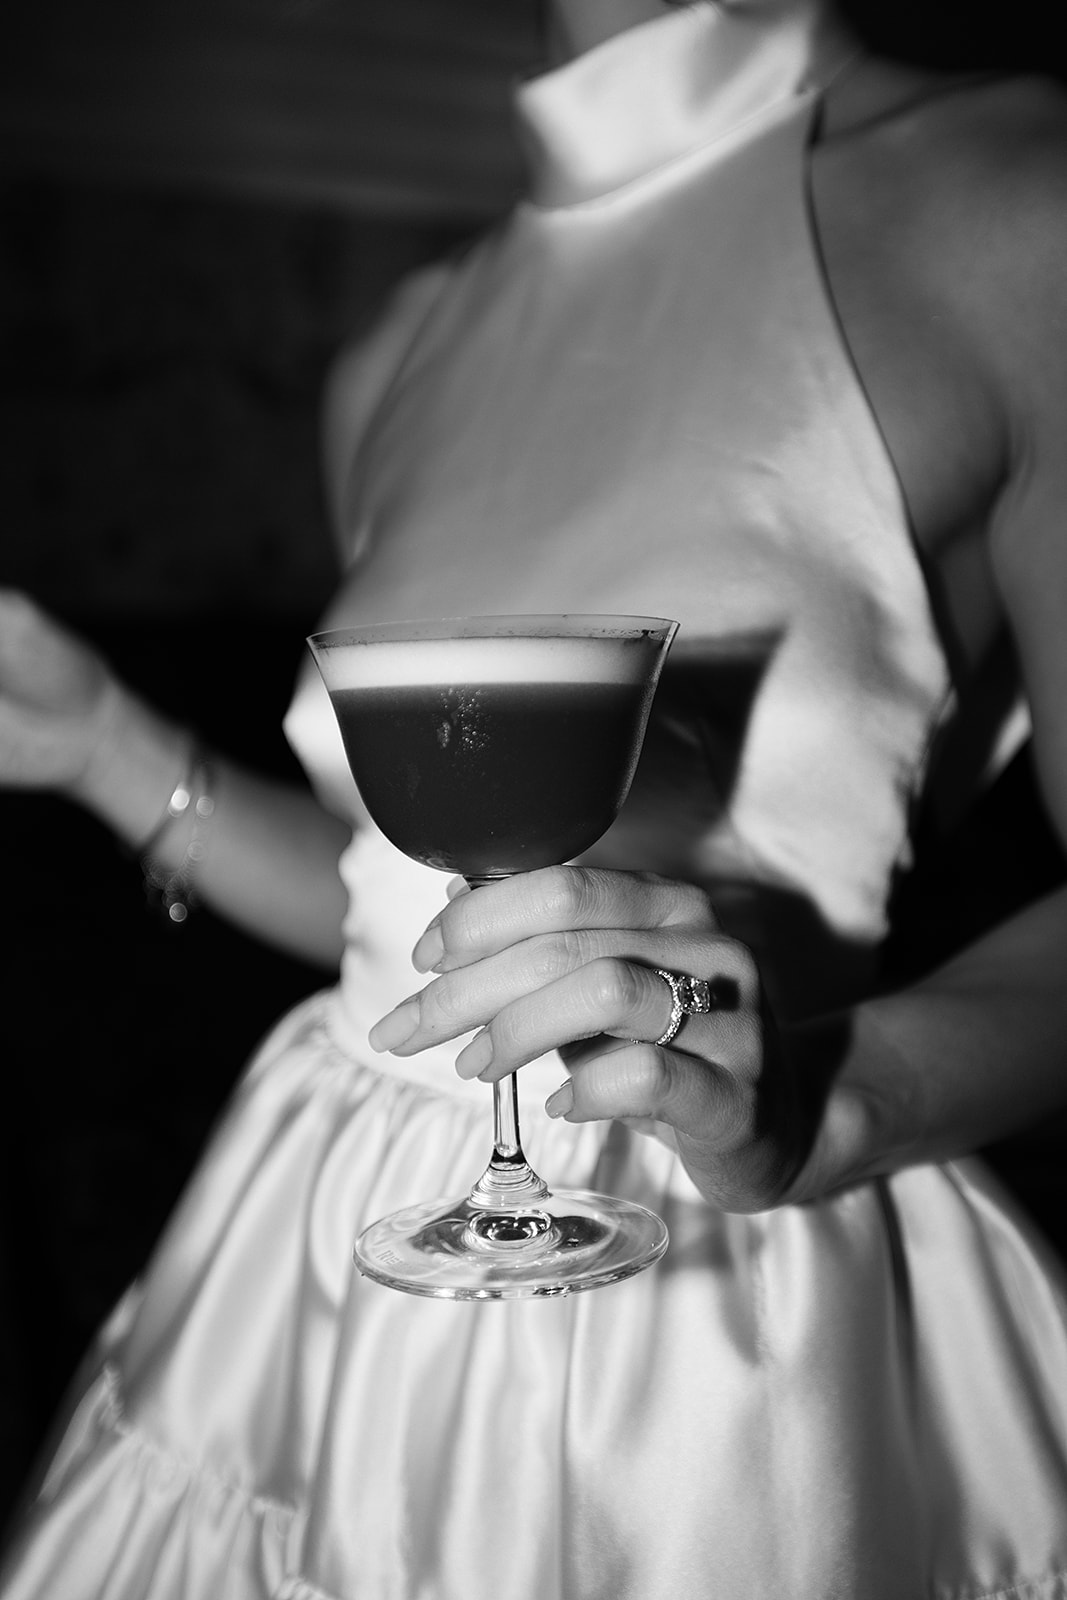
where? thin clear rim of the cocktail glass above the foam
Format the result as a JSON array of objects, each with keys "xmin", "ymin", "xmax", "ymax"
[{"xmin": 307, "ymin": 611, "xmax": 680, "ymax": 650}]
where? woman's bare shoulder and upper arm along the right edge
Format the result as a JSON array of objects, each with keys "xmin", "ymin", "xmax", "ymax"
[{"xmin": 814, "ymin": 62, "xmax": 1067, "ymax": 838}]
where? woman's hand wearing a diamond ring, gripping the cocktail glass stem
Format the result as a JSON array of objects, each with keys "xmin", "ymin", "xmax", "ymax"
[{"xmin": 371, "ymin": 867, "xmax": 809, "ymax": 1211}]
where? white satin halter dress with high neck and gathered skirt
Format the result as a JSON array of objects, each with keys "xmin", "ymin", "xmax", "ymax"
[{"xmin": 0, "ymin": 0, "xmax": 1067, "ymax": 1600}]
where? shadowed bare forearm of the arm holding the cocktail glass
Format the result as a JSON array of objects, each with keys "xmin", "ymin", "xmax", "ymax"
[{"xmin": 795, "ymin": 888, "xmax": 1067, "ymax": 1197}]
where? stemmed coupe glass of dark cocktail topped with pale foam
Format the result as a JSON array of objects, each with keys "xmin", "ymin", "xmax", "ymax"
[{"xmin": 309, "ymin": 616, "xmax": 677, "ymax": 1299}]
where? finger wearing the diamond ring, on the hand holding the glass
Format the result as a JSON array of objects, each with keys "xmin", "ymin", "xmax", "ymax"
[{"xmin": 456, "ymin": 936, "xmax": 758, "ymax": 1082}]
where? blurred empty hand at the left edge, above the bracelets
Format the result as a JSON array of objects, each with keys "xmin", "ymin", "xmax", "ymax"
[{"xmin": 0, "ymin": 589, "xmax": 122, "ymax": 794}]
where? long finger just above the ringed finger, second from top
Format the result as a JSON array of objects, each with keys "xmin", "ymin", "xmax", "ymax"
[{"xmin": 370, "ymin": 928, "xmax": 739, "ymax": 1056}]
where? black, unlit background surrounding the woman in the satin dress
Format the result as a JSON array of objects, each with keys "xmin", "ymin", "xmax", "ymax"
[{"xmin": 0, "ymin": 0, "xmax": 1067, "ymax": 1517}]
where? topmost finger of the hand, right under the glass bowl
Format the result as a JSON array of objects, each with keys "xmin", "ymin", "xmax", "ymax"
[{"xmin": 411, "ymin": 867, "xmax": 717, "ymax": 973}]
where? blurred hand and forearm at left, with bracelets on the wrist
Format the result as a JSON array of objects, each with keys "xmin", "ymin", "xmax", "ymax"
[{"xmin": 0, "ymin": 590, "xmax": 350, "ymax": 968}]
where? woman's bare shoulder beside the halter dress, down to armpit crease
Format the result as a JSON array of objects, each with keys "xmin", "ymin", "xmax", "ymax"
[{"xmin": 811, "ymin": 73, "xmax": 1067, "ymax": 576}]
